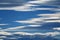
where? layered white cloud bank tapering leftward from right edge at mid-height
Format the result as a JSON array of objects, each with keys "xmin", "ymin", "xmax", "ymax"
[{"xmin": 15, "ymin": 12, "xmax": 60, "ymax": 25}]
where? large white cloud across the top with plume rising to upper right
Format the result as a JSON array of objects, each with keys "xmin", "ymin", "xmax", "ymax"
[{"xmin": 0, "ymin": 0, "xmax": 55, "ymax": 11}]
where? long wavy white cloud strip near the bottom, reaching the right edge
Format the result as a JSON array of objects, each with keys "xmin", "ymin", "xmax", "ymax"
[{"xmin": 13, "ymin": 32, "xmax": 60, "ymax": 36}]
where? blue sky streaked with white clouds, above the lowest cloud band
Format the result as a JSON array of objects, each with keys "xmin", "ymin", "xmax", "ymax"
[{"xmin": 0, "ymin": 0, "xmax": 60, "ymax": 39}]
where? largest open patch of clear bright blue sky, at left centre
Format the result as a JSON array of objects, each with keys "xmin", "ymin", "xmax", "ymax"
[{"xmin": 0, "ymin": 10, "xmax": 54, "ymax": 28}]
